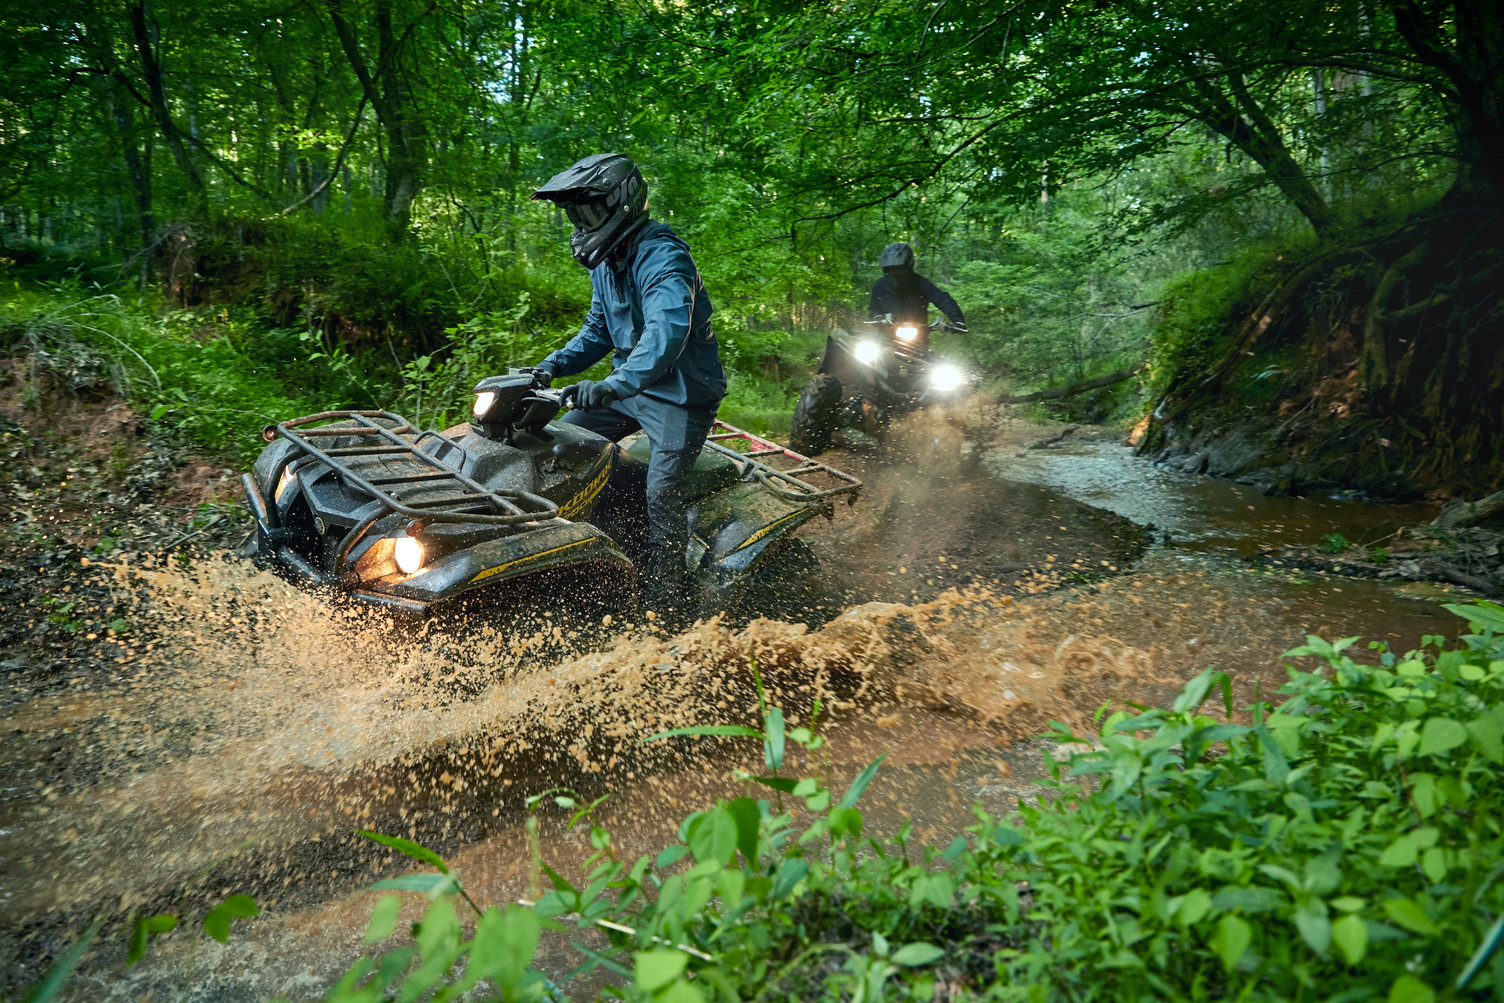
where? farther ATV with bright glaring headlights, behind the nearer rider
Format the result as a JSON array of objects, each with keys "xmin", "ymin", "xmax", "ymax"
[{"xmin": 788, "ymin": 317, "xmax": 972, "ymax": 456}]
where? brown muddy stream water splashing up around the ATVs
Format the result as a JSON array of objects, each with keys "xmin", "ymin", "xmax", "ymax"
[{"xmin": 0, "ymin": 420, "xmax": 1457, "ymax": 1000}]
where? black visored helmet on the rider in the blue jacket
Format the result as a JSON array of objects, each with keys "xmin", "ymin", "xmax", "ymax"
[{"xmin": 532, "ymin": 153, "xmax": 648, "ymax": 269}]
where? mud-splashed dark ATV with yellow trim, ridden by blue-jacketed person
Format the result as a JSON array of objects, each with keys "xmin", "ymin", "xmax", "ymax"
[{"xmin": 241, "ymin": 370, "xmax": 862, "ymax": 617}]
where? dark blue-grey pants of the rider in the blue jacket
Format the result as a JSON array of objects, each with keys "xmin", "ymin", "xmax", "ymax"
[{"xmin": 564, "ymin": 394, "xmax": 716, "ymax": 600}]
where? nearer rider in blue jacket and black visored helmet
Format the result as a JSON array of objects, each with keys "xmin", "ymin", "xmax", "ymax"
[{"xmin": 532, "ymin": 153, "xmax": 726, "ymax": 615}]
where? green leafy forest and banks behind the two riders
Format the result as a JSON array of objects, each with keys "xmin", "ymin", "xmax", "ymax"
[{"xmin": 0, "ymin": 0, "xmax": 1504, "ymax": 495}]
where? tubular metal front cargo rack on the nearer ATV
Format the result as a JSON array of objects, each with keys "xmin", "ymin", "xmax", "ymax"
[{"xmin": 262, "ymin": 411, "xmax": 559, "ymax": 535}]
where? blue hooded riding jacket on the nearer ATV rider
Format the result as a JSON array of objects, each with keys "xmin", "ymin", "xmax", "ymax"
[{"xmin": 541, "ymin": 220, "xmax": 726, "ymax": 408}]
